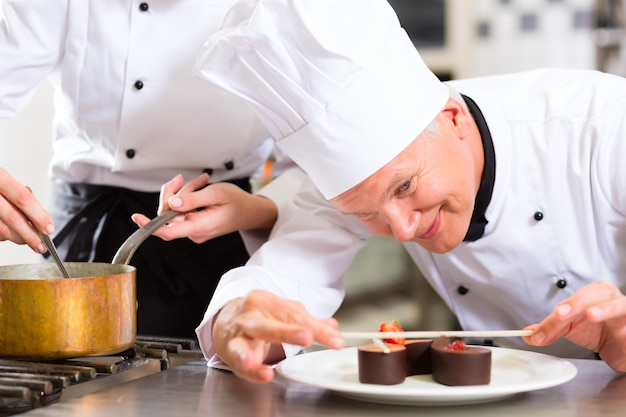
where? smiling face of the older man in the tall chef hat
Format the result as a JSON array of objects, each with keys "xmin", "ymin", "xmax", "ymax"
[{"xmin": 332, "ymin": 100, "xmax": 483, "ymax": 253}]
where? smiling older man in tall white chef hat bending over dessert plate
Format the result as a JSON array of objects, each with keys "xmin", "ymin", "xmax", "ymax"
[{"xmin": 154, "ymin": 0, "xmax": 626, "ymax": 382}]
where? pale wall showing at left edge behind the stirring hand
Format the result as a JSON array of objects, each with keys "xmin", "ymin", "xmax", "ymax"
[{"xmin": 0, "ymin": 82, "xmax": 52, "ymax": 265}]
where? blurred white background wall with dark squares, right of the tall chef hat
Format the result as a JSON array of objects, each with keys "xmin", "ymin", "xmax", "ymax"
[{"xmin": 416, "ymin": 0, "xmax": 595, "ymax": 78}]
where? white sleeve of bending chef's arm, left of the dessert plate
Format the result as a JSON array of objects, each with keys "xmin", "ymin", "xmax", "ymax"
[{"xmin": 196, "ymin": 177, "xmax": 370, "ymax": 359}]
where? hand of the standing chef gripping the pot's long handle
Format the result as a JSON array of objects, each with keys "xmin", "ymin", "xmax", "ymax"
[{"xmin": 132, "ymin": 174, "xmax": 277, "ymax": 243}]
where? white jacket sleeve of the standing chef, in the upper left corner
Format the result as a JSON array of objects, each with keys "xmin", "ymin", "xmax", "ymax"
[{"xmin": 0, "ymin": 0, "xmax": 68, "ymax": 118}]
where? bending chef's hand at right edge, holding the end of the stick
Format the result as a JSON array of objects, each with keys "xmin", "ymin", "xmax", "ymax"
[{"xmin": 524, "ymin": 281, "xmax": 626, "ymax": 372}]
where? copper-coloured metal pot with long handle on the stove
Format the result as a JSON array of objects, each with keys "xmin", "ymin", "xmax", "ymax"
[{"xmin": 0, "ymin": 212, "xmax": 176, "ymax": 360}]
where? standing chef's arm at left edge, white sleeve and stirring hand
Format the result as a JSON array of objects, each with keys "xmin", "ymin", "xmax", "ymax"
[{"xmin": 0, "ymin": 0, "xmax": 67, "ymax": 253}]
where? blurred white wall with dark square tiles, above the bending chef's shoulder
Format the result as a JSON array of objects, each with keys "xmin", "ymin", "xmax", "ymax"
[{"xmin": 468, "ymin": 0, "xmax": 595, "ymax": 76}]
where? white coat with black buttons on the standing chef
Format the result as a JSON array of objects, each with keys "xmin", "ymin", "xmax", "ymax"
[{"xmin": 0, "ymin": 0, "xmax": 273, "ymax": 191}]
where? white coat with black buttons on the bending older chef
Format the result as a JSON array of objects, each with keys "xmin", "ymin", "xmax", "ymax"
[{"xmin": 198, "ymin": 69, "xmax": 626, "ymax": 357}]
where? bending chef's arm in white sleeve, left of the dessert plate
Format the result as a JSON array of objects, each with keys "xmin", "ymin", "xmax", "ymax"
[{"xmin": 196, "ymin": 176, "xmax": 370, "ymax": 380}]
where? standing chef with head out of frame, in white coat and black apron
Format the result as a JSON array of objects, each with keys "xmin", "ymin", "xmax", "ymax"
[{"xmin": 0, "ymin": 0, "xmax": 302, "ymax": 337}]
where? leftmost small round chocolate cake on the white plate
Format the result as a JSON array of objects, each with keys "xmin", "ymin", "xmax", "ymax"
[{"xmin": 358, "ymin": 343, "xmax": 407, "ymax": 385}]
